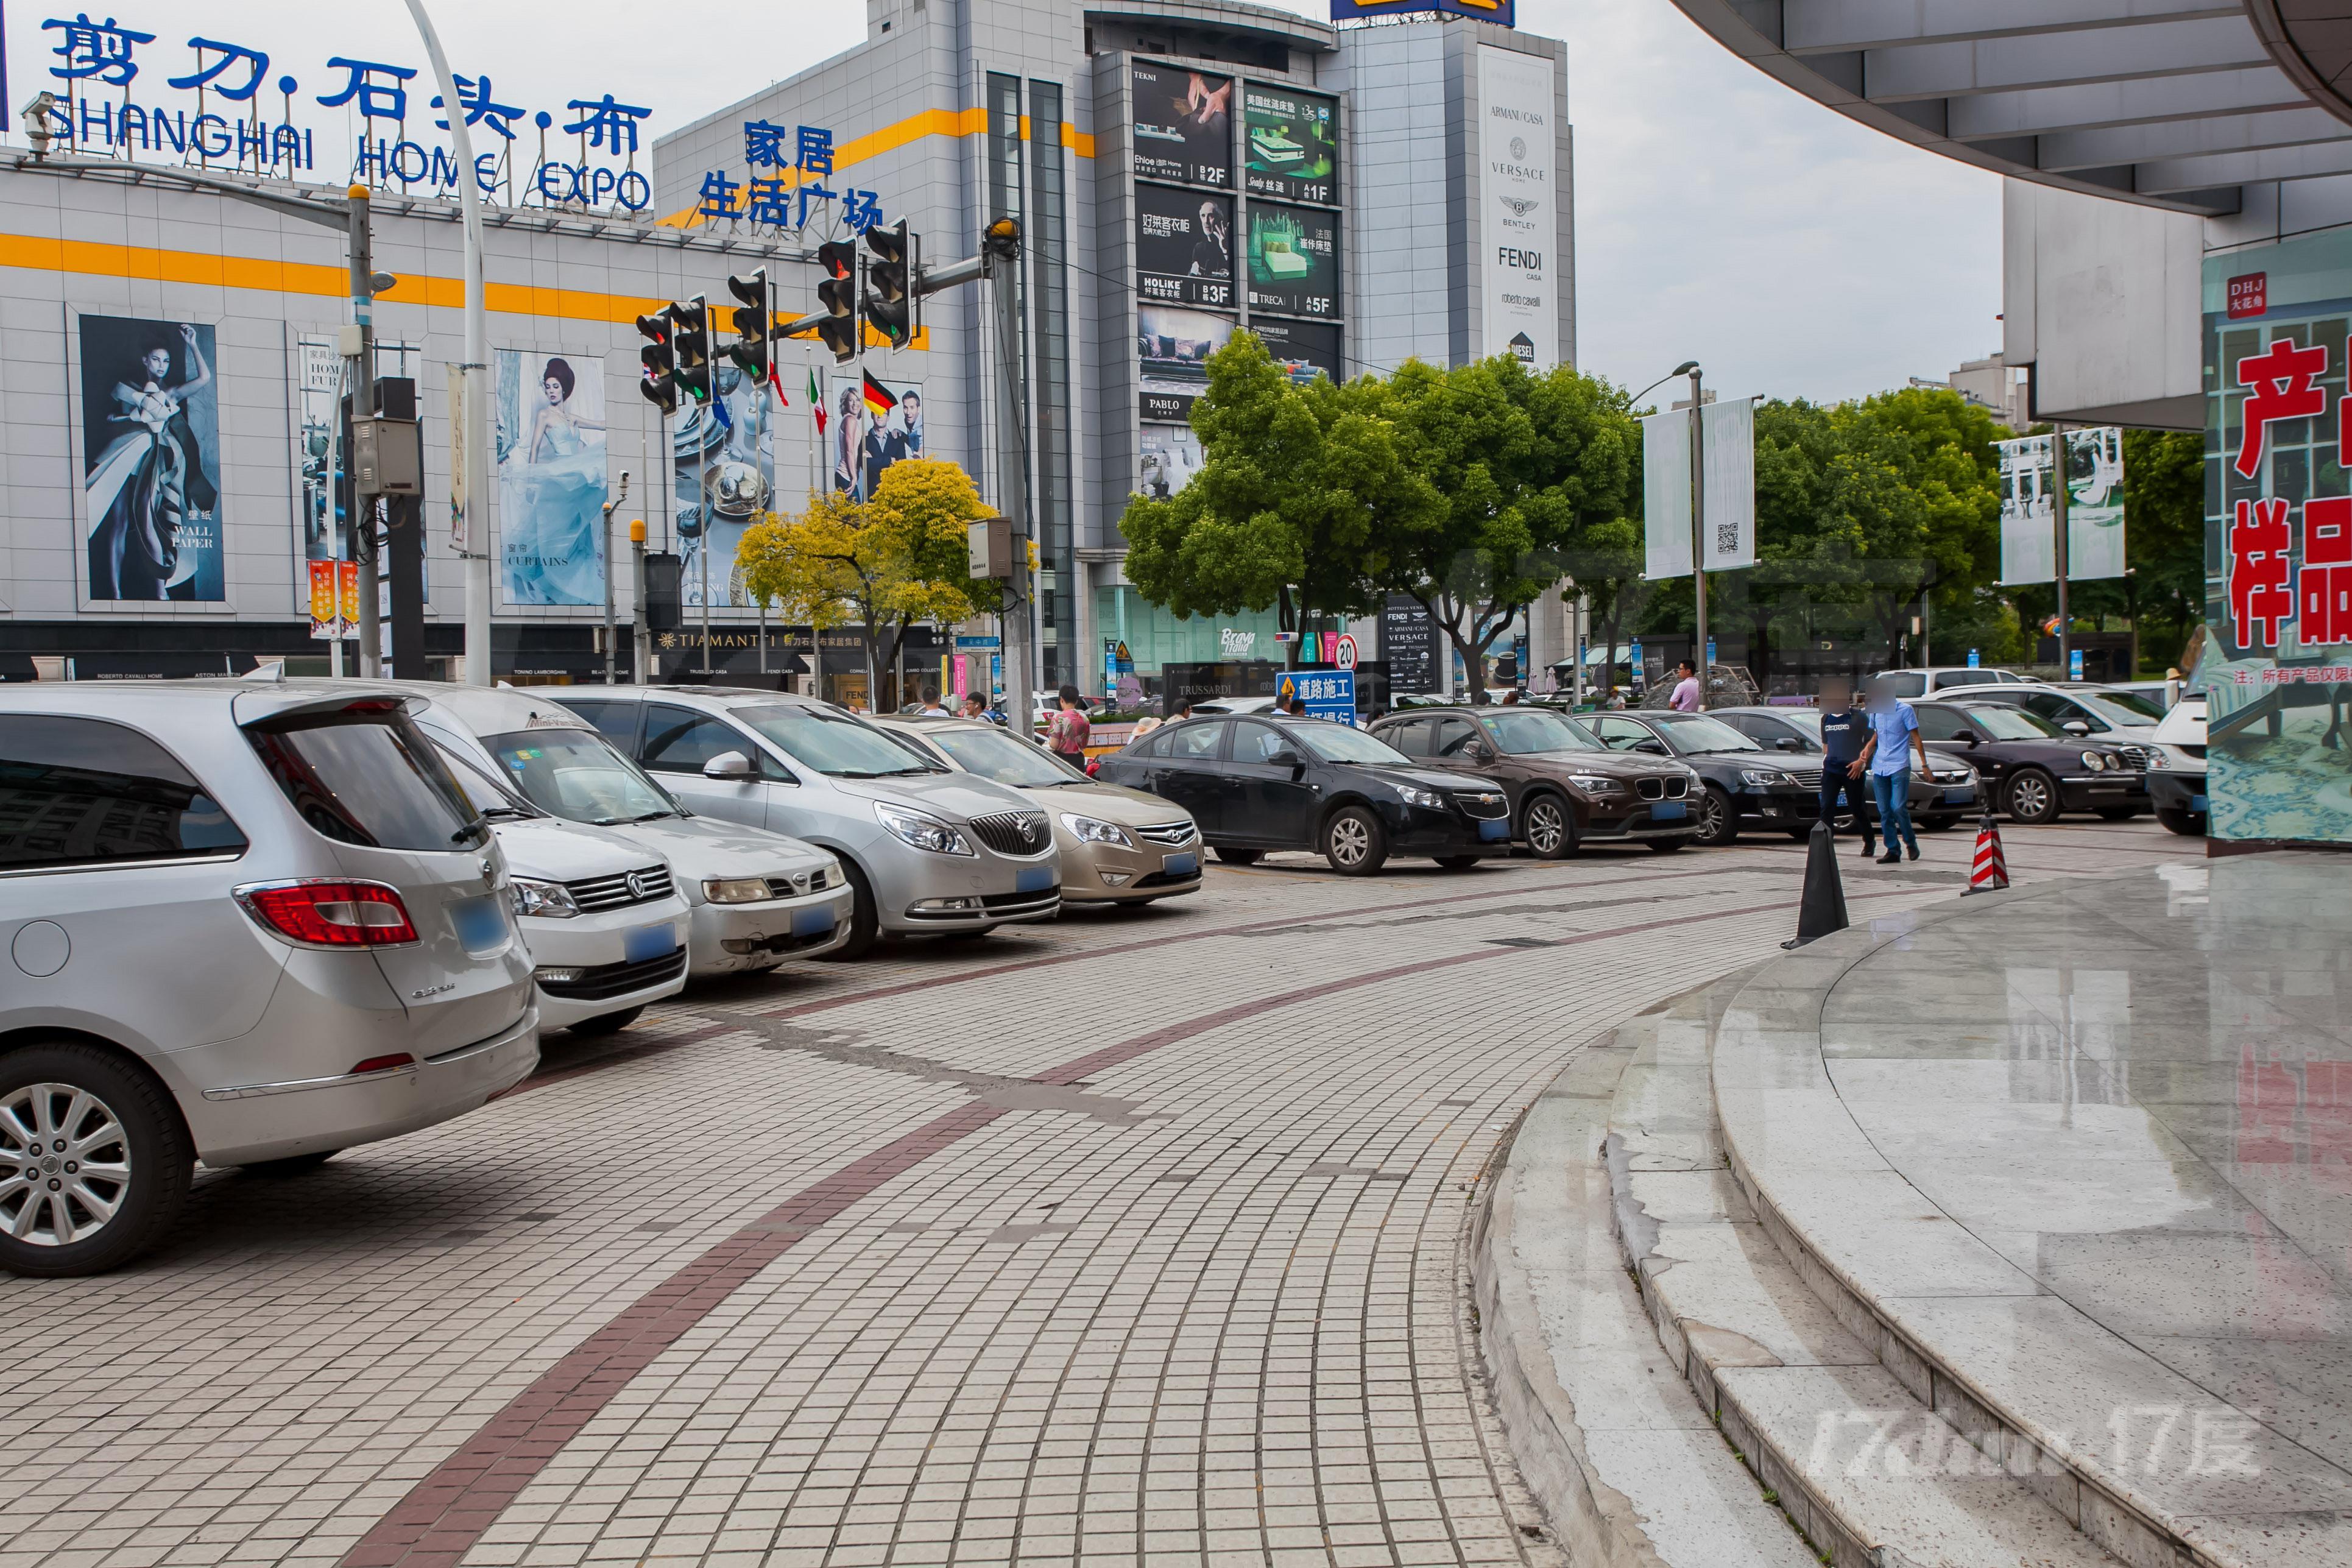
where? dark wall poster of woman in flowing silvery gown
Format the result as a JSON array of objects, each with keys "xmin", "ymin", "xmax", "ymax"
[{"xmin": 80, "ymin": 315, "xmax": 224, "ymax": 604}]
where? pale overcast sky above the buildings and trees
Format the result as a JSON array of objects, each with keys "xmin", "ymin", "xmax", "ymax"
[{"xmin": 7, "ymin": 0, "xmax": 2002, "ymax": 402}]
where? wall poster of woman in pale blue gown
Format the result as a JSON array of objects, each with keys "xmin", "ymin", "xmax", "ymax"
[{"xmin": 492, "ymin": 348, "xmax": 604, "ymax": 604}]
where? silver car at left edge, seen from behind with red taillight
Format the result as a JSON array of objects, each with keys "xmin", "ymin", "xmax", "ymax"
[{"xmin": 0, "ymin": 682, "xmax": 539, "ymax": 1274}]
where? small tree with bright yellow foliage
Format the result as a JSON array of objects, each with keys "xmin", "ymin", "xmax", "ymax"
[{"xmin": 736, "ymin": 459, "xmax": 995, "ymax": 712}]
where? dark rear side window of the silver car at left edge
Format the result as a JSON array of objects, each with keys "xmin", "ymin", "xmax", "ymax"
[{"xmin": 0, "ymin": 712, "xmax": 245, "ymax": 867}]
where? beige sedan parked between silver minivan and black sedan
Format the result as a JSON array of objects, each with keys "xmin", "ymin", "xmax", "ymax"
[{"xmin": 868, "ymin": 717, "xmax": 1202, "ymax": 903}]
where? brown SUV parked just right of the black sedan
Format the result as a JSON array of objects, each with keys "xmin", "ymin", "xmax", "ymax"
[{"xmin": 1371, "ymin": 708, "xmax": 1701, "ymax": 860}]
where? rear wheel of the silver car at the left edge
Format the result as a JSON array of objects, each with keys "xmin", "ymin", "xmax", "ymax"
[{"xmin": 0, "ymin": 1039, "xmax": 195, "ymax": 1279}]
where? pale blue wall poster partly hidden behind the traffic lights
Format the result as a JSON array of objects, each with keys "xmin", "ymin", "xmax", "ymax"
[{"xmin": 670, "ymin": 359, "xmax": 776, "ymax": 609}]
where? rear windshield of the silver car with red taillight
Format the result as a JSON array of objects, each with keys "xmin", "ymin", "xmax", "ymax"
[{"xmin": 245, "ymin": 703, "xmax": 489, "ymax": 851}]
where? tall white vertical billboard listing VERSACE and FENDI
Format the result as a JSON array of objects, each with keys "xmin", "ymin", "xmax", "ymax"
[{"xmin": 1477, "ymin": 44, "xmax": 1562, "ymax": 369}]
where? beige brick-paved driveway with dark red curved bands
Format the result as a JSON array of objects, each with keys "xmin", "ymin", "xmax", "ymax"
[{"xmin": 0, "ymin": 825, "xmax": 2178, "ymax": 1568}]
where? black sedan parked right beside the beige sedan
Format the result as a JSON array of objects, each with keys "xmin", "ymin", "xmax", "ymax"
[{"xmin": 1096, "ymin": 712, "xmax": 1510, "ymax": 877}]
